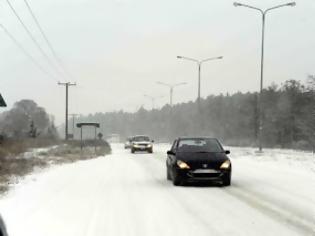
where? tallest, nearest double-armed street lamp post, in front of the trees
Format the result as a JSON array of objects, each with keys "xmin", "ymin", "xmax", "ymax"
[{"xmin": 233, "ymin": 2, "xmax": 296, "ymax": 152}]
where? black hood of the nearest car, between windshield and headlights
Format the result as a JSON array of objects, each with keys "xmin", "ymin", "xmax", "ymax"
[{"xmin": 176, "ymin": 152, "xmax": 229, "ymax": 169}]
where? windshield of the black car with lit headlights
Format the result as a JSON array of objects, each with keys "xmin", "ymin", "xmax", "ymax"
[{"xmin": 177, "ymin": 138, "xmax": 223, "ymax": 152}]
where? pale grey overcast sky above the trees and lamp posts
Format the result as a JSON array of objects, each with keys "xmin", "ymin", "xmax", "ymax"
[{"xmin": 0, "ymin": 0, "xmax": 315, "ymax": 124}]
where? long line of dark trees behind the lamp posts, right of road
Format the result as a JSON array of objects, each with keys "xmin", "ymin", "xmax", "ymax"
[{"xmin": 73, "ymin": 78, "xmax": 315, "ymax": 149}]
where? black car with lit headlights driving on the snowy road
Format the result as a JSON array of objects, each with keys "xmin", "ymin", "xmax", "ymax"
[{"xmin": 166, "ymin": 137, "xmax": 232, "ymax": 186}]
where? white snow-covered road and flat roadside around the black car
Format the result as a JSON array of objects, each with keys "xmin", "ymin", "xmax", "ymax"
[{"xmin": 0, "ymin": 145, "xmax": 315, "ymax": 236}]
